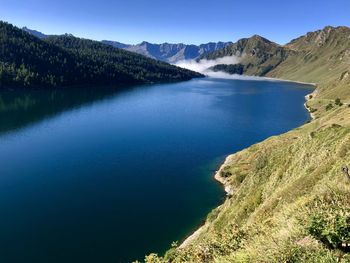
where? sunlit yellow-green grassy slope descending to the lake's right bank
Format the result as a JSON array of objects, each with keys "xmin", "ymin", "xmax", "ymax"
[{"xmin": 142, "ymin": 25, "xmax": 350, "ymax": 262}]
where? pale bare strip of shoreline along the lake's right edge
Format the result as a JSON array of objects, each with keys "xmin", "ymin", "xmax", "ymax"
[{"xmin": 178, "ymin": 78, "xmax": 317, "ymax": 249}]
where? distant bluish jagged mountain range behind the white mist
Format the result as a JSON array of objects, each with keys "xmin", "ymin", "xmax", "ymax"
[{"xmin": 102, "ymin": 40, "xmax": 231, "ymax": 63}]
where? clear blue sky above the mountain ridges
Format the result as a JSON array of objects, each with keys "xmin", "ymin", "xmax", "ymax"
[{"xmin": 0, "ymin": 0, "xmax": 350, "ymax": 44}]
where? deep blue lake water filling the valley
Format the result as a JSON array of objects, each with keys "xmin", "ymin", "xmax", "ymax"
[{"xmin": 0, "ymin": 78, "xmax": 311, "ymax": 263}]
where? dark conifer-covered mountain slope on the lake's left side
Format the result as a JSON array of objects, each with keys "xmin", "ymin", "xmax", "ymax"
[{"xmin": 0, "ymin": 22, "xmax": 201, "ymax": 87}]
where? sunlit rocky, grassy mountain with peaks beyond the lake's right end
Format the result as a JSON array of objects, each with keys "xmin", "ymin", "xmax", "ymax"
[{"xmin": 202, "ymin": 26, "xmax": 350, "ymax": 100}]
